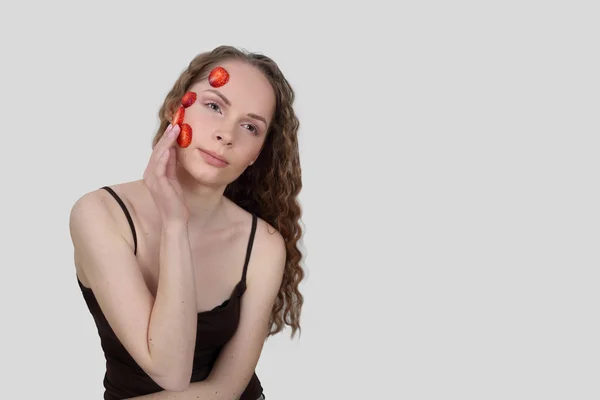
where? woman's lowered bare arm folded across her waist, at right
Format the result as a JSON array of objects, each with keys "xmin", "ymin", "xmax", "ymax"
[{"xmin": 125, "ymin": 226, "xmax": 286, "ymax": 400}]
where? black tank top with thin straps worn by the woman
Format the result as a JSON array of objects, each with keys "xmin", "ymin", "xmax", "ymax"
[{"xmin": 77, "ymin": 186, "xmax": 263, "ymax": 400}]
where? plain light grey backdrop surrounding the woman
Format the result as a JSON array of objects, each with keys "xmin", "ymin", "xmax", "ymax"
[{"xmin": 0, "ymin": 1, "xmax": 600, "ymax": 400}]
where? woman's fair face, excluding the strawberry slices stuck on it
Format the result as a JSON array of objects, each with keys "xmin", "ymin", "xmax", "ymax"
[{"xmin": 175, "ymin": 61, "xmax": 275, "ymax": 186}]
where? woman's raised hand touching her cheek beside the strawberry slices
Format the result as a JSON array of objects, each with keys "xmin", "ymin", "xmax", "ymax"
[{"xmin": 144, "ymin": 125, "xmax": 190, "ymax": 224}]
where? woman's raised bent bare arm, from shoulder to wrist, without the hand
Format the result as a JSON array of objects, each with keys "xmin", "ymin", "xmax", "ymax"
[{"xmin": 69, "ymin": 191, "xmax": 196, "ymax": 391}]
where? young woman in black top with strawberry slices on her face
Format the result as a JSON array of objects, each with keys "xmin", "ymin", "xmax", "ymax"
[{"xmin": 70, "ymin": 46, "xmax": 304, "ymax": 400}]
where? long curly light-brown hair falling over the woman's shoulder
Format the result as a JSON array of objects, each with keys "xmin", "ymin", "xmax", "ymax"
[{"xmin": 152, "ymin": 46, "xmax": 304, "ymax": 337}]
